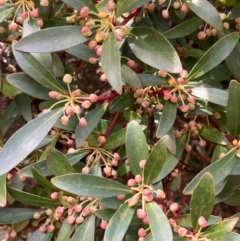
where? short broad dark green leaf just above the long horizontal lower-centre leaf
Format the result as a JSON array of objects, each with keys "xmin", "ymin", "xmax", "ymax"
[{"xmin": 46, "ymin": 147, "xmax": 76, "ymax": 176}]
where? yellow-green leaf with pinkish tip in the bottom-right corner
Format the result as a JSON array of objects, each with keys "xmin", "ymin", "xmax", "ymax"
[{"xmin": 203, "ymin": 218, "xmax": 239, "ymax": 240}]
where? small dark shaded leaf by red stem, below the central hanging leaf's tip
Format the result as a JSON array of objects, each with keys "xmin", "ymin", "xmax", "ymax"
[{"xmin": 109, "ymin": 93, "xmax": 136, "ymax": 113}]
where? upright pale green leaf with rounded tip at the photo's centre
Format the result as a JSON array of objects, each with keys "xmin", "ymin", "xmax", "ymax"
[{"xmin": 126, "ymin": 121, "xmax": 148, "ymax": 175}]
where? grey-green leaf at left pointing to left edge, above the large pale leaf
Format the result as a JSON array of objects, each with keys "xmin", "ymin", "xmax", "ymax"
[{"xmin": 7, "ymin": 73, "xmax": 51, "ymax": 100}]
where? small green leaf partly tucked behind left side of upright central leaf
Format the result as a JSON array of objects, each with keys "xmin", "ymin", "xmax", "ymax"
[{"xmin": 104, "ymin": 128, "xmax": 127, "ymax": 149}]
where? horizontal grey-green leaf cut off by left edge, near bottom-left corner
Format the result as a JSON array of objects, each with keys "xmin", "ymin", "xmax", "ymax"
[{"xmin": 0, "ymin": 208, "xmax": 41, "ymax": 224}]
